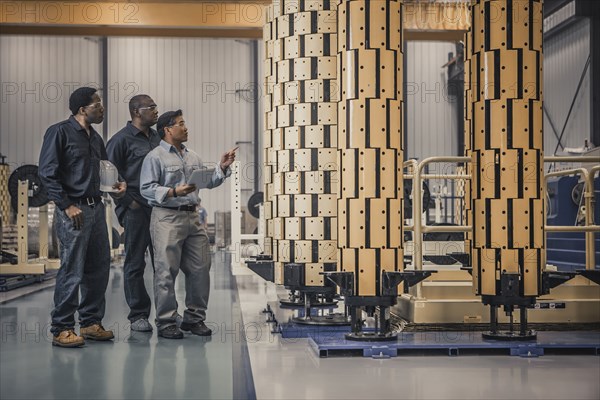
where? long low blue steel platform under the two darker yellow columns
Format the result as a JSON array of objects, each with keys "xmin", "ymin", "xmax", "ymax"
[{"xmin": 308, "ymin": 327, "xmax": 600, "ymax": 358}]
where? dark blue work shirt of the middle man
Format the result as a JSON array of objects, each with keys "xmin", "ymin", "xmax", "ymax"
[{"xmin": 106, "ymin": 121, "xmax": 160, "ymax": 220}]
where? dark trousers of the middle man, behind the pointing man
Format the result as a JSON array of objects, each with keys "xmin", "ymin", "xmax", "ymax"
[{"xmin": 123, "ymin": 206, "xmax": 154, "ymax": 322}]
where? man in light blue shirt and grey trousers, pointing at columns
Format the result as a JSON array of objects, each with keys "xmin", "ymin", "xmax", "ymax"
[{"xmin": 140, "ymin": 110, "xmax": 236, "ymax": 339}]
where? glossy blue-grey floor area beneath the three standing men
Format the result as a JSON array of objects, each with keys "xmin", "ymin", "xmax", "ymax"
[{"xmin": 0, "ymin": 256, "xmax": 247, "ymax": 399}]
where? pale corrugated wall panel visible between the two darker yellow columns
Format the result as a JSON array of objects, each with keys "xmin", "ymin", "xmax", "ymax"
[{"xmin": 405, "ymin": 41, "xmax": 458, "ymax": 160}]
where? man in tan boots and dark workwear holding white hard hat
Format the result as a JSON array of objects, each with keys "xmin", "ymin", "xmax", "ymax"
[{"xmin": 39, "ymin": 87, "xmax": 127, "ymax": 347}]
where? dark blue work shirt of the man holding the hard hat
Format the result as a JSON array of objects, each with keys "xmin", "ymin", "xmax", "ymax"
[{"xmin": 38, "ymin": 116, "xmax": 107, "ymax": 210}]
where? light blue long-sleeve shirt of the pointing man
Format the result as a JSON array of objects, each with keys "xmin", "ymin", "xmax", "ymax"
[{"xmin": 140, "ymin": 140, "xmax": 231, "ymax": 207}]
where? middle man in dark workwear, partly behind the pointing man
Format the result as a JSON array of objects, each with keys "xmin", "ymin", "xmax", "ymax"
[{"xmin": 106, "ymin": 94, "xmax": 160, "ymax": 332}]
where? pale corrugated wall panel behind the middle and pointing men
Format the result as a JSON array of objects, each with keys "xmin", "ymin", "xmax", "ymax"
[{"xmin": 108, "ymin": 38, "xmax": 253, "ymax": 222}]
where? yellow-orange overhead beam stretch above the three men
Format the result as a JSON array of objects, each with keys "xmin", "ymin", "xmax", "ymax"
[{"xmin": 0, "ymin": 1, "xmax": 266, "ymax": 38}]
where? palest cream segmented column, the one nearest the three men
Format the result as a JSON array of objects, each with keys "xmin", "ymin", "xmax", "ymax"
[{"xmin": 264, "ymin": 0, "xmax": 339, "ymax": 314}]
